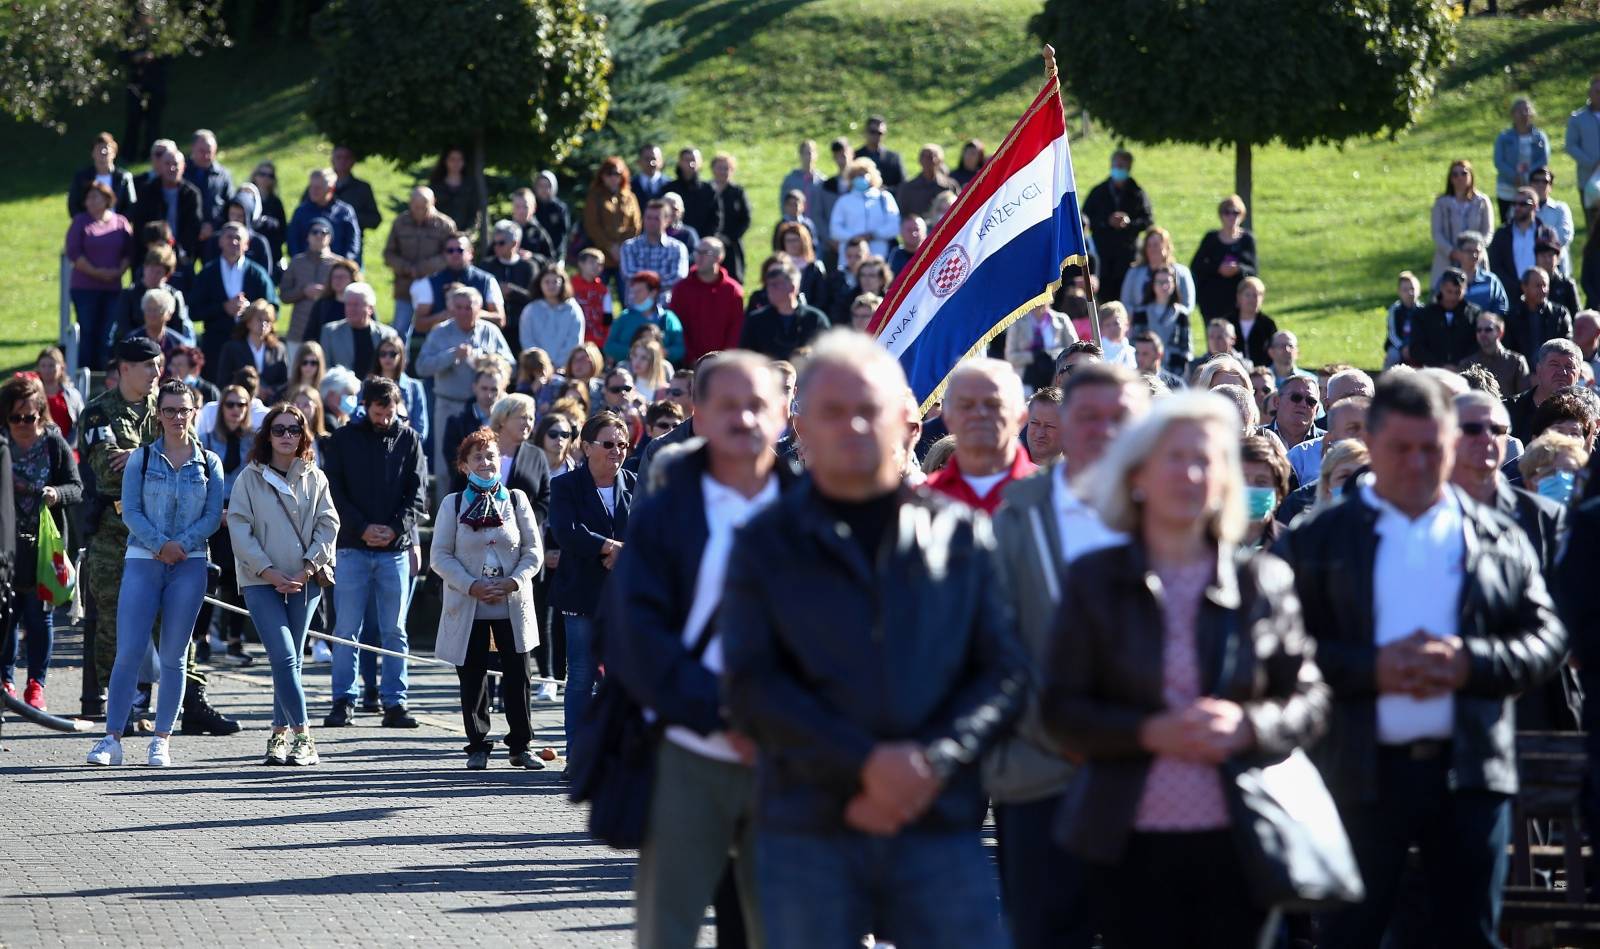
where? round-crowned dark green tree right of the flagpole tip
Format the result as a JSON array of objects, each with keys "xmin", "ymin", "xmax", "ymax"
[{"xmin": 1029, "ymin": 0, "xmax": 1456, "ymax": 224}]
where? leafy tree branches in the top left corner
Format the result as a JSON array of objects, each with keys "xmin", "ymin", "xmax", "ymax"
[{"xmin": 0, "ymin": 0, "xmax": 227, "ymax": 131}]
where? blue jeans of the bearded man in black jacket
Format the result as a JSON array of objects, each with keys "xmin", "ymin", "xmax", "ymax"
[{"xmin": 333, "ymin": 547, "xmax": 411, "ymax": 709}]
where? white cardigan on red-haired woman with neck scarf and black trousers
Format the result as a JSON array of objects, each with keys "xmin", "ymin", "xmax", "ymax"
[{"xmin": 429, "ymin": 488, "xmax": 544, "ymax": 666}]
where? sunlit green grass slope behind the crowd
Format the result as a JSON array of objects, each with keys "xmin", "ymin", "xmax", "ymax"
[{"xmin": 0, "ymin": 0, "xmax": 1600, "ymax": 374}]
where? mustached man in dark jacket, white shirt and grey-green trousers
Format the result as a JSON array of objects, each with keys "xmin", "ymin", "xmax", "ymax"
[{"xmin": 605, "ymin": 352, "xmax": 794, "ymax": 946}]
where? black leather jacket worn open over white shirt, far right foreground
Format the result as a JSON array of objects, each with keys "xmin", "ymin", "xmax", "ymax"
[{"xmin": 1282, "ymin": 487, "xmax": 1566, "ymax": 802}]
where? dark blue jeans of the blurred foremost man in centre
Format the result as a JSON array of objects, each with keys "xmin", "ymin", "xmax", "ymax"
[{"xmin": 755, "ymin": 831, "xmax": 1010, "ymax": 949}]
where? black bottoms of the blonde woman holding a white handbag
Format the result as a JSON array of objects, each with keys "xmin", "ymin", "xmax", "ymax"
[{"xmin": 1090, "ymin": 831, "xmax": 1277, "ymax": 949}]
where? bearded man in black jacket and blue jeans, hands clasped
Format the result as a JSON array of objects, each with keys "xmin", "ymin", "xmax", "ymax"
[{"xmin": 323, "ymin": 376, "xmax": 427, "ymax": 728}]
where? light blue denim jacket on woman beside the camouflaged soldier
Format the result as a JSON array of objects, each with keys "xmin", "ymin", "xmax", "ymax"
[{"xmin": 122, "ymin": 435, "xmax": 222, "ymax": 554}]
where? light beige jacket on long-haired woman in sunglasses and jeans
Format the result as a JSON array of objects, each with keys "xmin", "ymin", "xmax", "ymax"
[{"xmin": 227, "ymin": 461, "xmax": 339, "ymax": 589}]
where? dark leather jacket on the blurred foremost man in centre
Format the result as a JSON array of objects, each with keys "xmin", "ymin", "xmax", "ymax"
[{"xmin": 717, "ymin": 482, "xmax": 1029, "ymax": 834}]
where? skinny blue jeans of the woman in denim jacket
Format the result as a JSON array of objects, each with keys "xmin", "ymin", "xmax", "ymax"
[{"xmin": 106, "ymin": 557, "xmax": 206, "ymax": 735}]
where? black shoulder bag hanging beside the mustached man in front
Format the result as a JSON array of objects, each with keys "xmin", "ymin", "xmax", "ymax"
[{"xmin": 566, "ymin": 595, "xmax": 717, "ymax": 850}]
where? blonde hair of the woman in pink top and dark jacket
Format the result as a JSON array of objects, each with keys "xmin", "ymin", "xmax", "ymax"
[{"xmin": 1080, "ymin": 390, "xmax": 1248, "ymax": 546}]
